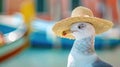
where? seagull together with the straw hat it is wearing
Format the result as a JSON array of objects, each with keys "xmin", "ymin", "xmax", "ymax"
[{"xmin": 52, "ymin": 6, "xmax": 113, "ymax": 67}]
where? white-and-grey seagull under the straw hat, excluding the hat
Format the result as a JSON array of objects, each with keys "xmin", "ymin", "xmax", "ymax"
[{"xmin": 67, "ymin": 22, "xmax": 112, "ymax": 67}]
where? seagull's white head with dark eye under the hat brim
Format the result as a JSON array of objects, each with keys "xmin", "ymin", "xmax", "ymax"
[{"xmin": 70, "ymin": 22, "xmax": 95, "ymax": 39}]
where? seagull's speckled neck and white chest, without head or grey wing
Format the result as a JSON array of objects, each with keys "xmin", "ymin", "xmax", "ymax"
[{"xmin": 67, "ymin": 36, "xmax": 97, "ymax": 67}]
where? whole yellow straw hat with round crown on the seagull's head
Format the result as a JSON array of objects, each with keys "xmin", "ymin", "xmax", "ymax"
[{"xmin": 53, "ymin": 6, "xmax": 113, "ymax": 39}]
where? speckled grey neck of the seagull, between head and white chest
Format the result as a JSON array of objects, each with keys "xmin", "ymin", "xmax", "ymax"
[{"xmin": 71, "ymin": 36, "xmax": 95, "ymax": 55}]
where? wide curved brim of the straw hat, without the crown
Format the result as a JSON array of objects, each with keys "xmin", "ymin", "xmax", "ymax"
[{"xmin": 53, "ymin": 17, "xmax": 113, "ymax": 39}]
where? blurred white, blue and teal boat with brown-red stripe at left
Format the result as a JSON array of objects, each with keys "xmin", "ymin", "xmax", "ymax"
[{"xmin": 0, "ymin": 13, "xmax": 28, "ymax": 62}]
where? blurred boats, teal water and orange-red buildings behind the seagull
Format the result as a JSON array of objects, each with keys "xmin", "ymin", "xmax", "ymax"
[{"xmin": 0, "ymin": 0, "xmax": 120, "ymax": 67}]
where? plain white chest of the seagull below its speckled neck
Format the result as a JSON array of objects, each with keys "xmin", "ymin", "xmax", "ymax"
[{"xmin": 68, "ymin": 54, "xmax": 96, "ymax": 67}]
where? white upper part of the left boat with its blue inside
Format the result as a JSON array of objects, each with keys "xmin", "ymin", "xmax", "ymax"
[{"xmin": 0, "ymin": 14, "xmax": 26, "ymax": 44}]
